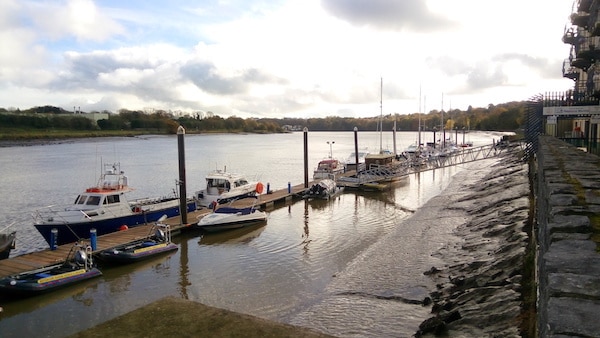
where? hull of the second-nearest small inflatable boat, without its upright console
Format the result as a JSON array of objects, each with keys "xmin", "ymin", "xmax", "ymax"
[{"xmin": 98, "ymin": 242, "xmax": 179, "ymax": 264}]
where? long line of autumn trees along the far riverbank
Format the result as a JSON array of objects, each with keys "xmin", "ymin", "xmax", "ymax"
[{"xmin": 0, "ymin": 101, "xmax": 528, "ymax": 134}]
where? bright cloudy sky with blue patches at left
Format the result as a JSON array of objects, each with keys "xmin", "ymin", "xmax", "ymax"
[{"xmin": 0, "ymin": 0, "xmax": 573, "ymax": 118}]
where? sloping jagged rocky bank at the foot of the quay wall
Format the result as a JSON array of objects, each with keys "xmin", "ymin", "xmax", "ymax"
[{"xmin": 415, "ymin": 149, "xmax": 531, "ymax": 337}]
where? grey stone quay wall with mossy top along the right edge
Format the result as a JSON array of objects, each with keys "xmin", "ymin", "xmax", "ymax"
[{"xmin": 531, "ymin": 136, "xmax": 600, "ymax": 337}]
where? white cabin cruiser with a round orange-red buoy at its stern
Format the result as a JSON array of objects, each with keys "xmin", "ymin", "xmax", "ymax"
[{"xmin": 194, "ymin": 168, "xmax": 264, "ymax": 208}]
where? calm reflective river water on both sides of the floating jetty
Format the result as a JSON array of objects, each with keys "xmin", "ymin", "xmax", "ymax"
[{"xmin": 0, "ymin": 132, "xmax": 501, "ymax": 337}]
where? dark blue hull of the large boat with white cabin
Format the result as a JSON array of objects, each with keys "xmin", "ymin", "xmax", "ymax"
[{"xmin": 34, "ymin": 202, "xmax": 196, "ymax": 247}]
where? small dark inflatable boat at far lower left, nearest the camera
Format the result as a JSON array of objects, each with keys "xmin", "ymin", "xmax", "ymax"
[{"xmin": 0, "ymin": 242, "xmax": 102, "ymax": 295}]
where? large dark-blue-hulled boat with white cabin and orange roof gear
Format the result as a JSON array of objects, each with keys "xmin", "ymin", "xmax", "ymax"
[{"xmin": 33, "ymin": 163, "xmax": 196, "ymax": 247}]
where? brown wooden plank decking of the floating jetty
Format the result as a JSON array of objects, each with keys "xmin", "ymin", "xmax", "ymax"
[{"xmin": 0, "ymin": 182, "xmax": 312, "ymax": 278}]
